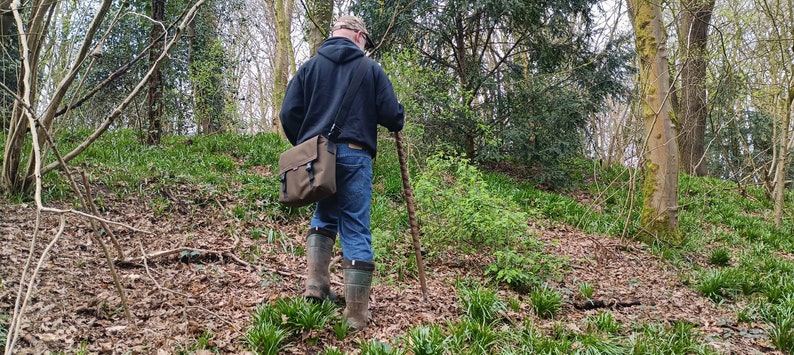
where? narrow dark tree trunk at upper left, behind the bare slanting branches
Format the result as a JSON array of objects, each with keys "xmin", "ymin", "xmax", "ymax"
[{"xmin": 146, "ymin": 0, "xmax": 165, "ymax": 145}]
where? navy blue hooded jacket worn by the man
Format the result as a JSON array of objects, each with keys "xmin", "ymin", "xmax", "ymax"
[{"xmin": 279, "ymin": 37, "xmax": 405, "ymax": 157}]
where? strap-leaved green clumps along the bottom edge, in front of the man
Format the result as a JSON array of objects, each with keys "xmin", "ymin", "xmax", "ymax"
[{"xmin": 242, "ymin": 279, "xmax": 716, "ymax": 355}]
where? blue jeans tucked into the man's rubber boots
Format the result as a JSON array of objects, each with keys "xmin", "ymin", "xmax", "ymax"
[{"xmin": 311, "ymin": 143, "xmax": 373, "ymax": 261}]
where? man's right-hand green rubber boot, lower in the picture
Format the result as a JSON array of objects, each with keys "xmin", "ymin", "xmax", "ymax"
[{"xmin": 342, "ymin": 260, "xmax": 375, "ymax": 332}]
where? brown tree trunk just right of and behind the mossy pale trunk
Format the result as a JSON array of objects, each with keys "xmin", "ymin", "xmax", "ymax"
[{"xmin": 678, "ymin": 0, "xmax": 714, "ymax": 176}]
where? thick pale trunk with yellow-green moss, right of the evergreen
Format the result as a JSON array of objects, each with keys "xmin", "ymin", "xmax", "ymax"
[{"xmin": 627, "ymin": 0, "xmax": 682, "ymax": 245}]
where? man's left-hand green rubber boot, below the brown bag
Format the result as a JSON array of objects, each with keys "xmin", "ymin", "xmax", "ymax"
[{"xmin": 303, "ymin": 228, "xmax": 336, "ymax": 302}]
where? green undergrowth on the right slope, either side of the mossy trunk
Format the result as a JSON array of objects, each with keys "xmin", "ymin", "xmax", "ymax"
[{"xmin": 485, "ymin": 168, "xmax": 794, "ymax": 353}]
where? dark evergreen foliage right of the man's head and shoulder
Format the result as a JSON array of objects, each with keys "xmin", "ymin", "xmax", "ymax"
[{"xmin": 364, "ymin": 0, "xmax": 632, "ymax": 185}]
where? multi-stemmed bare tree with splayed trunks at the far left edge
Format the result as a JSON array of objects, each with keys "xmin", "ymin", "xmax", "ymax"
[{"xmin": 0, "ymin": 0, "xmax": 204, "ymax": 194}]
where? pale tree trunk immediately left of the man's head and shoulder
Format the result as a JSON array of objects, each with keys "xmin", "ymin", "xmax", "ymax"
[{"xmin": 272, "ymin": 0, "xmax": 294, "ymax": 138}]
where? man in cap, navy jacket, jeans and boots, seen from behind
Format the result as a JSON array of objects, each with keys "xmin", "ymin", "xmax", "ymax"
[{"xmin": 280, "ymin": 16, "xmax": 404, "ymax": 331}]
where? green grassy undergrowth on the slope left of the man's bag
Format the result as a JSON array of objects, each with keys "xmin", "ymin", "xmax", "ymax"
[{"xmin": 33, "ymin": 130, "xmax": 300, "ymax": 219}]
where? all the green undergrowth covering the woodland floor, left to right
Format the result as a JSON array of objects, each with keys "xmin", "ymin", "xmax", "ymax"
[{"xmin": 9, "ymin": 130, "xmax": 794, "ymax": 354}]
